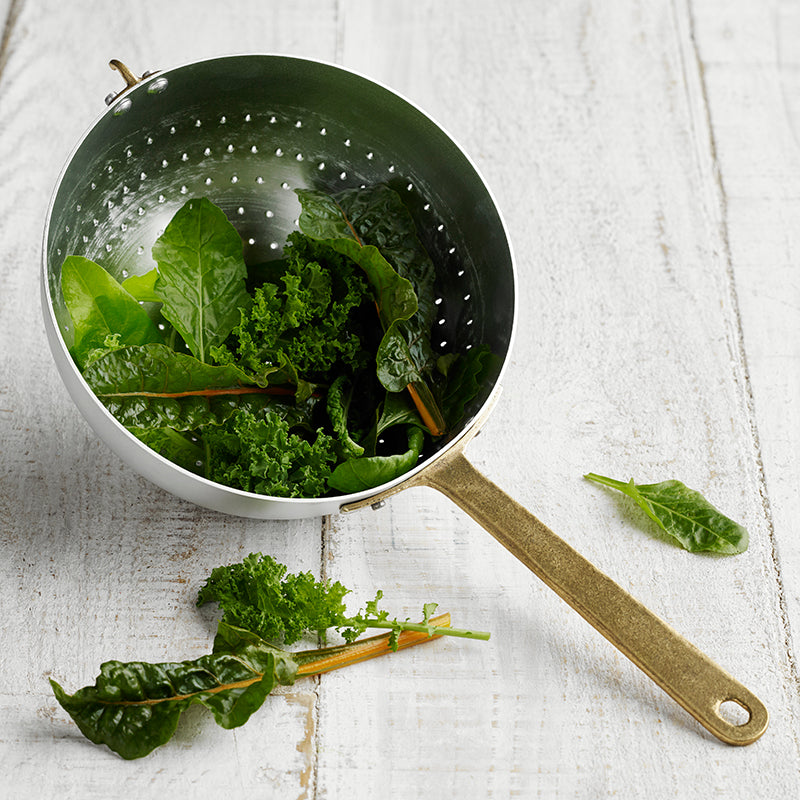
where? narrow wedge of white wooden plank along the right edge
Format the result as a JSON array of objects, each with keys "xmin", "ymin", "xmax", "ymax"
[{"xmin": 695, "ymin": 3, "xmax": 800, "ymax": 700}]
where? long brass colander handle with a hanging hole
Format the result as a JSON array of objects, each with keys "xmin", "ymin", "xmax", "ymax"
[{"xmin": 415, "ymin": 448, "xmax": 769, "ymax": 745}]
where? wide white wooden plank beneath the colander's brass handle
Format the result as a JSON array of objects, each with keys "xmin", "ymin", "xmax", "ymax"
[{"xmin": 319, "ymin": 2, "xmax": 798, "ymax": 797}]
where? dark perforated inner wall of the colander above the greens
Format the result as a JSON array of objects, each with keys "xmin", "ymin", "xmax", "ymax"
[{"xmin": 45, "ymin": 55, "xmax": 514, "ymax": 456}]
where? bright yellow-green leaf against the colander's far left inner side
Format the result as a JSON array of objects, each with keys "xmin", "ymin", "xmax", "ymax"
[{"xmin": 61, "ymin": 256, "xmax": 162, "ymax": 366}]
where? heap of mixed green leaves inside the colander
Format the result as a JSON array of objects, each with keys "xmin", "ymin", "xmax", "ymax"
[{"xmin": 61, "ymin": 185, "xmax": 492, "ymax": 497}]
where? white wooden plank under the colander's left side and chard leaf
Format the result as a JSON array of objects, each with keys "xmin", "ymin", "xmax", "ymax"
[{"xmin": 0, "ymin": 2, "xmax": 336, "ymax": 798}]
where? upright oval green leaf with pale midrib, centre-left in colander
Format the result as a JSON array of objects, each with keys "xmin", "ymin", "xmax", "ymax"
[{"xmin": 153, "ymin": 198, "xmax": 250, "ymax": 361}]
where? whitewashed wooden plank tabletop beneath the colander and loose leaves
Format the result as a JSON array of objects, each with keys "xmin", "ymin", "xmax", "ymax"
[{"xmin": 0, "ymin": 0, "xmax": 800, "ymax": 800}]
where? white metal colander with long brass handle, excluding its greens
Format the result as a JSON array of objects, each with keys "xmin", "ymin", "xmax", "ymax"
[{"xmin": 42, "ymin": 55, "xmax": 768, "ymax": 744}]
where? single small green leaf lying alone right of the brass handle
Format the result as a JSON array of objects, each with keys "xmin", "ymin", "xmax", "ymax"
[{"xmin": 584, "ymin": 472, "xmax": 749, "ymax": 555}]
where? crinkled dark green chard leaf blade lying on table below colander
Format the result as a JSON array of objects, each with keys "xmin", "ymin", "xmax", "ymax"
[{"xmin": 50, "ymin": 622, "xmax": 297, "ymax": 759}]
